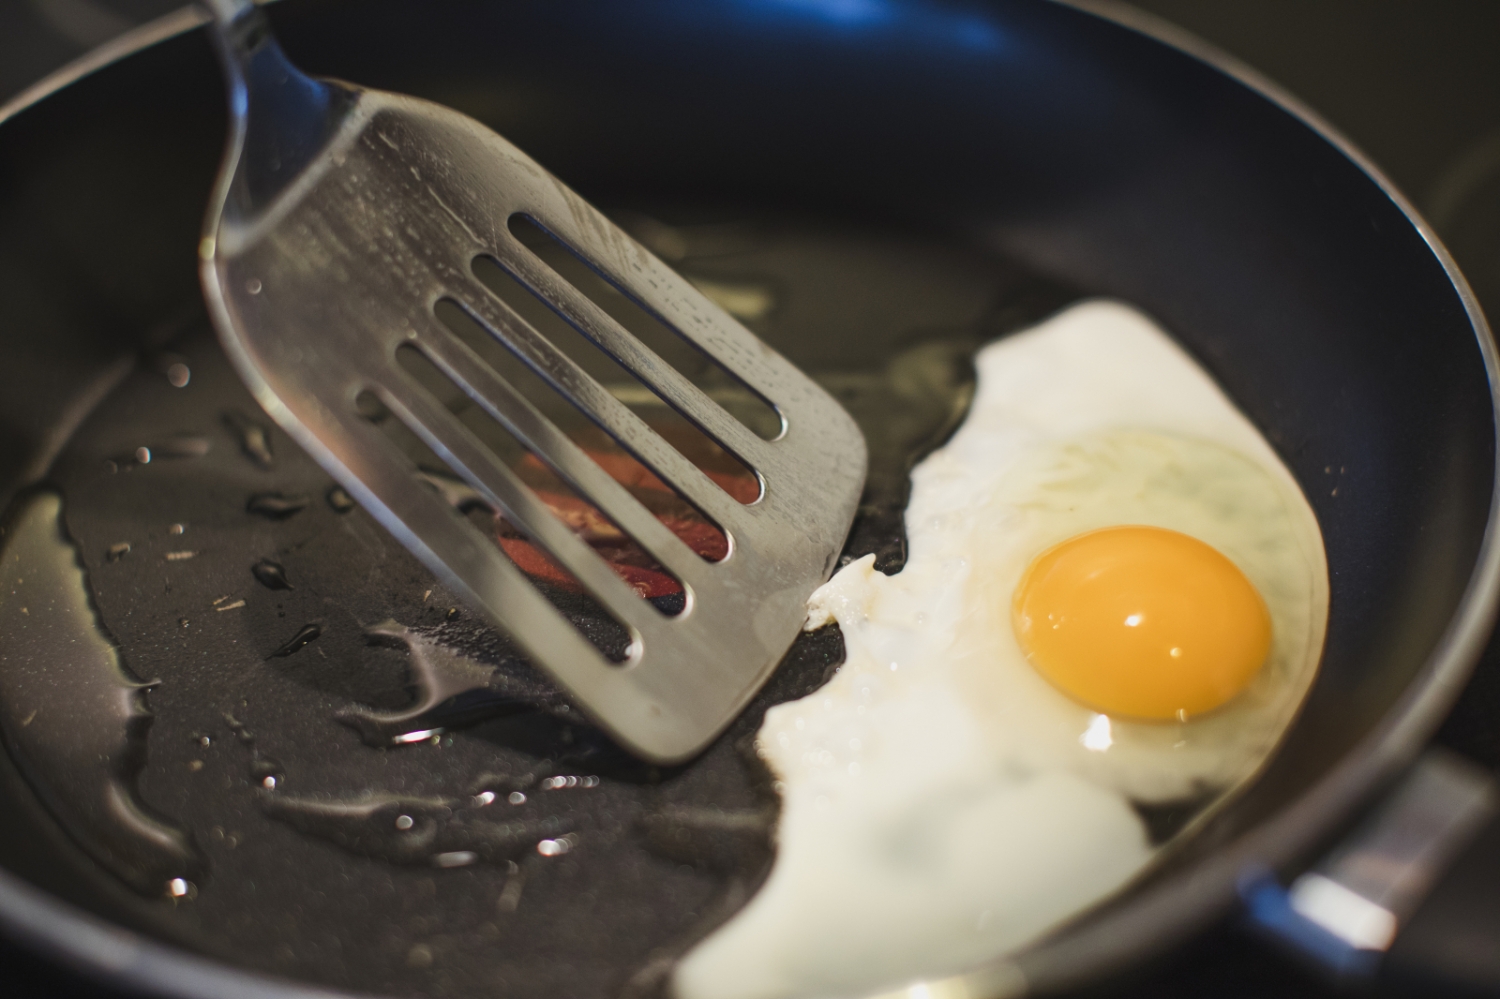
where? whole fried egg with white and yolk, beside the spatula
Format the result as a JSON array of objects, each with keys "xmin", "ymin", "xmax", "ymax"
[{"xmin": 674, "ymin": 302, "xmax": 1328, "ymax": 999}]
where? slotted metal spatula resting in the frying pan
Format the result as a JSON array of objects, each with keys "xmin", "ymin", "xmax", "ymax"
[{"xmin": 200, "ymin": 0, "xmax": 866, "ymax": 764}]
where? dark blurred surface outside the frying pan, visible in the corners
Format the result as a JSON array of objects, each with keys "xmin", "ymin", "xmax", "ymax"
[{"xmin": 0, "ymin": 0, "xmax": 1500, "ymax": 999}]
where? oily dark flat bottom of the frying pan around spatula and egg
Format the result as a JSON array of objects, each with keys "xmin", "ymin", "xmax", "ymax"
[{"xmin": 0, "ymin": 210, "xmax": 1302, "ymax": 998}]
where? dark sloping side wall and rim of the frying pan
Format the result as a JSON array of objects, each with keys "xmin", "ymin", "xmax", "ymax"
[{"xmin": 0, "ymin": 0, "xmax": 1500, "ymax": 999}]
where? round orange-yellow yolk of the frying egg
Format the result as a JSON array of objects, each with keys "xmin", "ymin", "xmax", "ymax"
[{"xmin": 1011, "ymin": 527, "xmax": 1271, "ymax": 722}]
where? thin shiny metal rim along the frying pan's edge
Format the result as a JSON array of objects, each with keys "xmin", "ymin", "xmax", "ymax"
[{"xmin": 0, "ymin": 0, "xmax": 1500, "ymax": 999}]
